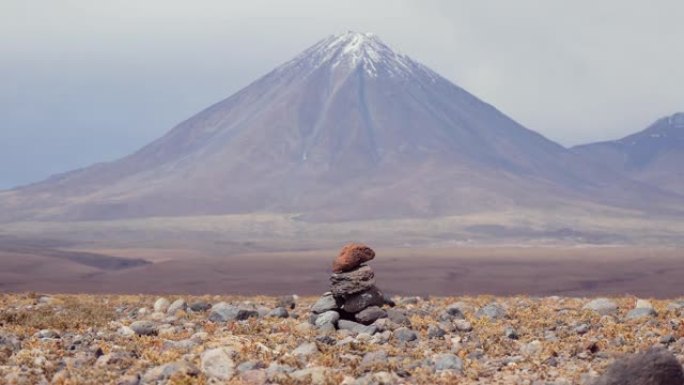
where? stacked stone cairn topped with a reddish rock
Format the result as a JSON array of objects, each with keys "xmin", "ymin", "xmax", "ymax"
[{"xmin": 310, "ymin": 243, "xmax": 394, "ymax": 334}]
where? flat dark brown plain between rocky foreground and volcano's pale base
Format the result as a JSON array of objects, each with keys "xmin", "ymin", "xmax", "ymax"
[{"xmin": 0, "ymin": 245, "xmax": 684, "ymax": 297}]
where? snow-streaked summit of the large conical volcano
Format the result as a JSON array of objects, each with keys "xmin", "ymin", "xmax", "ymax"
[{"xmin": 286, "ymin": 31, "xmax": 436, "ymax": 77}]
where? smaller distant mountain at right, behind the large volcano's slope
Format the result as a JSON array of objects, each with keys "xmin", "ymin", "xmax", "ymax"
[{"xmin": 573, "ymin": 112, "xmax": 684, "ymax": 195}]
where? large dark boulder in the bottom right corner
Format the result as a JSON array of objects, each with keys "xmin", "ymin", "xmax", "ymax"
[{"xmin": 594, "ymin": 348, "xmax": 684, "ymax": 385}]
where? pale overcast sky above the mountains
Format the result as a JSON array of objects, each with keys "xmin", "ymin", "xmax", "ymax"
[{"xmin": 0, "ymin": 0, "xmax": 684, "ymax": 188}]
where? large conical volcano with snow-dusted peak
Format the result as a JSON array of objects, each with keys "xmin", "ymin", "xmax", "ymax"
[{"xmin": 0, "ymin": 32, "xmax": 671, "ymax": 221}]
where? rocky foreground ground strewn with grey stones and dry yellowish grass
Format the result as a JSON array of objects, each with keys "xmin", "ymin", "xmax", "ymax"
[{"xmin": 0, "ymin": 294, "xmax": 684, "ymax": 385}]
